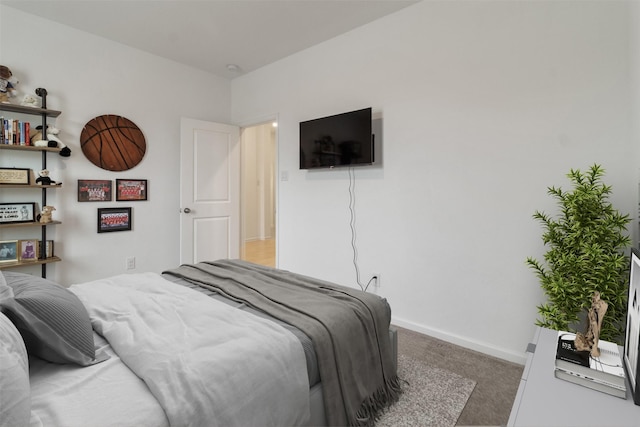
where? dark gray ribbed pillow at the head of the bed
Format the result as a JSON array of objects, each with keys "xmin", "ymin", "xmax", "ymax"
[{"xmin": 0, "ymin": 272, "xmax": 108, "ymax": 366}]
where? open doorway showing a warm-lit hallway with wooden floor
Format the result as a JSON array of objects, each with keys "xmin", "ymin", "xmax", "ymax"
[{"xmin": 240, "ymin": 122, "xmax": 277, "ymax": 267}]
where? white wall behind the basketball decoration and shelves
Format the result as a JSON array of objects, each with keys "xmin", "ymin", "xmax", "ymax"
[{"xmin": 0, "ymin": 5, "xmax": 230, "ymax": 284}]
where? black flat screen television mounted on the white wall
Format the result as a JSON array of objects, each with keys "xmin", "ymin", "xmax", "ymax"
[{"xmin": 300, "ymin": 108, "xmax": 375, "ymax": 169}]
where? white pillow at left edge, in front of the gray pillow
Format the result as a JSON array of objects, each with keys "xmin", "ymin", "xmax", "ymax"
[{"xmin": 0, "ymin": 310, "xmax": 31, "ymax": 427}]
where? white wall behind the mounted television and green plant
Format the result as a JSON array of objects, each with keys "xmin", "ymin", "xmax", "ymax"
[{"xmin": 232, "ymin": 1, "xmax": 638, "ymax": 362}]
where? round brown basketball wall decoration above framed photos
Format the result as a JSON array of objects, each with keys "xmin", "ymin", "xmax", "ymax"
[{"xmin": 80, "ymin": 114, "xmax": 147, "ymax": 171}]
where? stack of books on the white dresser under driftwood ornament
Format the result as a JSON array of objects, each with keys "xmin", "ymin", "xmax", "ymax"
[{"xmin": 554, "ymin": 331, "xmax": 627, "ymax": 399}]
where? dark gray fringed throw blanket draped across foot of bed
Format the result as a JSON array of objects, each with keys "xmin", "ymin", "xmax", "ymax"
[{"xmin": 164, "ymin": 260, "xmax": 401, "ymax": 426}]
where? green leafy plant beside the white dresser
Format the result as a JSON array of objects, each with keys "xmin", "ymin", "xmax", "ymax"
[{"xmin": 527, "ymin": 165, "xmax": 631, "ymax": 343}]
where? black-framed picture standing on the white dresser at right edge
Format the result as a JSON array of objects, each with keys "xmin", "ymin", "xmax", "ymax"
[{"xmin": 622, "ymin": 248, "xmax": 640, "ymax": 406}]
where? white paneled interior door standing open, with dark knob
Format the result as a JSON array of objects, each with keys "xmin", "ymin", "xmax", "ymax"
[{"xmin": 180, "ymin": 118, "xmax": 240, "ymax": 264}]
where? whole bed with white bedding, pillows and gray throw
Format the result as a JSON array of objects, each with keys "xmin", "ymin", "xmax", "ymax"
[{"xmin": 0, "ymin": 260, "xmax": 401, "ymax": 427}]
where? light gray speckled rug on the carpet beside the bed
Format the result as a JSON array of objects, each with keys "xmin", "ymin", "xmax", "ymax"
[{"xmin": 376, "ymin": 354, "xmax": 476, "ymax": 427}]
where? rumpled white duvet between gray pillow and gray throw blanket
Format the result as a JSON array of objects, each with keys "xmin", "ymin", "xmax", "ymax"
[{"xmin": 66, "ymin": 273, "xmax": 309, "ymax": 426}]
